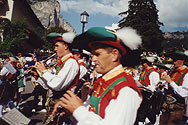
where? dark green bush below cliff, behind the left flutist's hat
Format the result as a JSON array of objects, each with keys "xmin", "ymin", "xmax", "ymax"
[{"xmin": 42, "ymin": 26, "xmax": 67, "ymax": 51}]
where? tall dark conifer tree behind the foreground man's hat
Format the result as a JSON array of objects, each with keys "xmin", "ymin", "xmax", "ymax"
[{"xmin": 119, "ymin": 0, "xmax": 164, "ymax": 52}]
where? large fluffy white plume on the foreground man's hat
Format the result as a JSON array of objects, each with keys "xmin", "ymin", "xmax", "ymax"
[{"xmin": 115, "ymin": 27, "xmax": 142, "ymax": 50}]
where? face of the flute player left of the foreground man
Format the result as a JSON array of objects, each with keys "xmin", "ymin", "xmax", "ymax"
[{"xmin": 54, "ymin": 42, "xmax": 66, "ymax": 58}]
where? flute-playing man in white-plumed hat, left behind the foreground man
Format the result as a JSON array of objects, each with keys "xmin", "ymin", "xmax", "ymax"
[{"xmin": 35, "ymin": 32, "xmax": 80, "ymax": 124}]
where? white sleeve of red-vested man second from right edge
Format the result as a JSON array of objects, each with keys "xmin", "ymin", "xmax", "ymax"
[{"xmin": 149, "ymin": 71, "xmax": 160, "ymax": 91}]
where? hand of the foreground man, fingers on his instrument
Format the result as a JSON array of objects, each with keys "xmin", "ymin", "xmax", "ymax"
[{"xmin": 60, "ymin": 90, "xmax": 83, "ymax": 113}]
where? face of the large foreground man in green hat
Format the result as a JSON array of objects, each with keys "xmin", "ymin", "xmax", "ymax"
[{"xmin": 92, "ymin": 48, "xmax": 113, "ymax": 74}]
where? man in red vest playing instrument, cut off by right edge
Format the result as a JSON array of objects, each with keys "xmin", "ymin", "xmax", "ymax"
[{"xmin": 162, "ymin": 51, "xmax": 188, "ymax": 124}]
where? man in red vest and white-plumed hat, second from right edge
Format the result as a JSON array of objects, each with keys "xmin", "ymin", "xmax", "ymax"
[{"xmin": 137, "ymin": 56, "xmax": 160, "ymax": 125}]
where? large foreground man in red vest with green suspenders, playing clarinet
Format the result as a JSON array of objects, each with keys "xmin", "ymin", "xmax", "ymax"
[{"xmin": 53, "ymin": 27, "xmax": 142, "ymax": 125}]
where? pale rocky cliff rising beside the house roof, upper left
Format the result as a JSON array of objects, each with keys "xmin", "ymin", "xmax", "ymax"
[{"xmin": 28, "ymin": 0, "xmax": 76, "ymax": 32}]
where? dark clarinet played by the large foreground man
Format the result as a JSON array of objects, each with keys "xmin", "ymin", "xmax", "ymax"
[{"xmin": 44, "ymin": 64, "xmax": 95, "ymax": 125}]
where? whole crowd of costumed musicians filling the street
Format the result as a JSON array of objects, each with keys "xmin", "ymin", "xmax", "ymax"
[{"xmin": 0, "ymin": 27, "xmax": 188, "ymax": 125}]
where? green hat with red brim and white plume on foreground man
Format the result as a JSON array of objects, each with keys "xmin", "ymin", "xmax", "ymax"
[{"xmin": 73, "ymin": 27, "xmax": 141, "ymax": 55}]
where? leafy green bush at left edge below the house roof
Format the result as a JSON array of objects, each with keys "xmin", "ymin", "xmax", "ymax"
[{"xmin": 0, "ymin": 19, "xmax": 28, "ymax": 54}]
